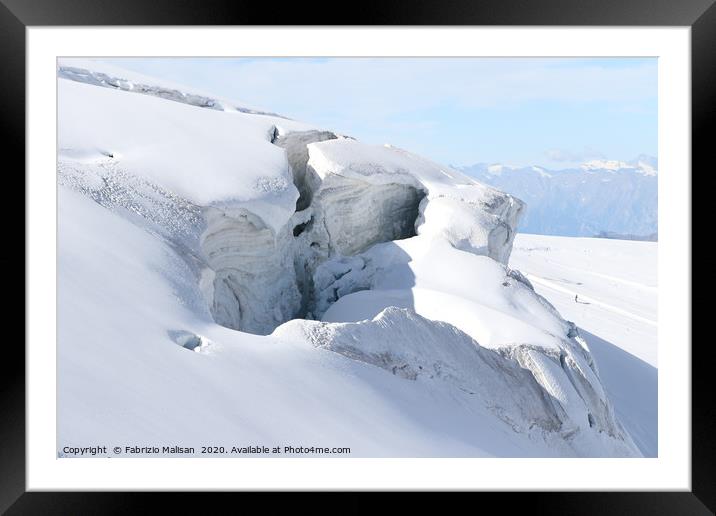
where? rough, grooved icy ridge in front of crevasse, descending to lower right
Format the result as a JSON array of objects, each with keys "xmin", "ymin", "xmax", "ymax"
[{"xmin": 272, "ymin": 307, "xmax": 640, "ymax": 457}]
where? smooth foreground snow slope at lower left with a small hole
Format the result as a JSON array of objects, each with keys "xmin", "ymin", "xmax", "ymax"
[{"xmin": 58, "ymin": 187, "xmax": 554, "ymax": 456}]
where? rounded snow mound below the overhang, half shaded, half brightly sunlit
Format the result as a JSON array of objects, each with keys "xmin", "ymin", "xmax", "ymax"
[{"xmin": 317, "ymin": 237, "xmax": 569, "ymax": 350}]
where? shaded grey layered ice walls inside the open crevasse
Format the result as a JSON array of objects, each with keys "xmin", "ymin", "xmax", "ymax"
[{"xmin": 201, "ymin": 131, "xmax": 425, "ymax": 335}]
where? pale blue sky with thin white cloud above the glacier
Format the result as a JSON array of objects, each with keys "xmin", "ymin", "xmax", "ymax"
[{"xmin": 105, "ymin": 58, "xmax": 657, "ymax": 168}]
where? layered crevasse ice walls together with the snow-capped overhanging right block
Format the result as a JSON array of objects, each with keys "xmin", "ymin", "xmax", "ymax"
[{"xmin": 194, "ymin": 130, "xmax": 522, "ymax": 334}]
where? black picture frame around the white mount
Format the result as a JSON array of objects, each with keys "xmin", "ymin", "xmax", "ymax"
[{"xmin": 0, "ymin": 0, "xmax": 716, "ymax": 515}]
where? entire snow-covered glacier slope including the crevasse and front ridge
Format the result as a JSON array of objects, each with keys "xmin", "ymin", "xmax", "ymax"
[{"xmin": 58, "ymin": 59, "xmax": 641, "ymax": 456}]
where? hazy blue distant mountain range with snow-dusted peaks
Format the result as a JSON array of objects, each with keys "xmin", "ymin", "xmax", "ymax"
[{"xmin": 462, "ymin": 155, "xmax": 658, "ymax": 240}]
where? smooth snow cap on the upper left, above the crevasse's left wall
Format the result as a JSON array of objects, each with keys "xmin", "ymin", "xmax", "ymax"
[{"xmin": 58, "ymin": 79, "xmax": 316, "ymax": 232}]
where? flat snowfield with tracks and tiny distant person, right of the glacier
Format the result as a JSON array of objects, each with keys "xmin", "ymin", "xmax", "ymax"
[{"xmin": 510, "ymin": 234, "xmax": 658, "ymax": 457}]
